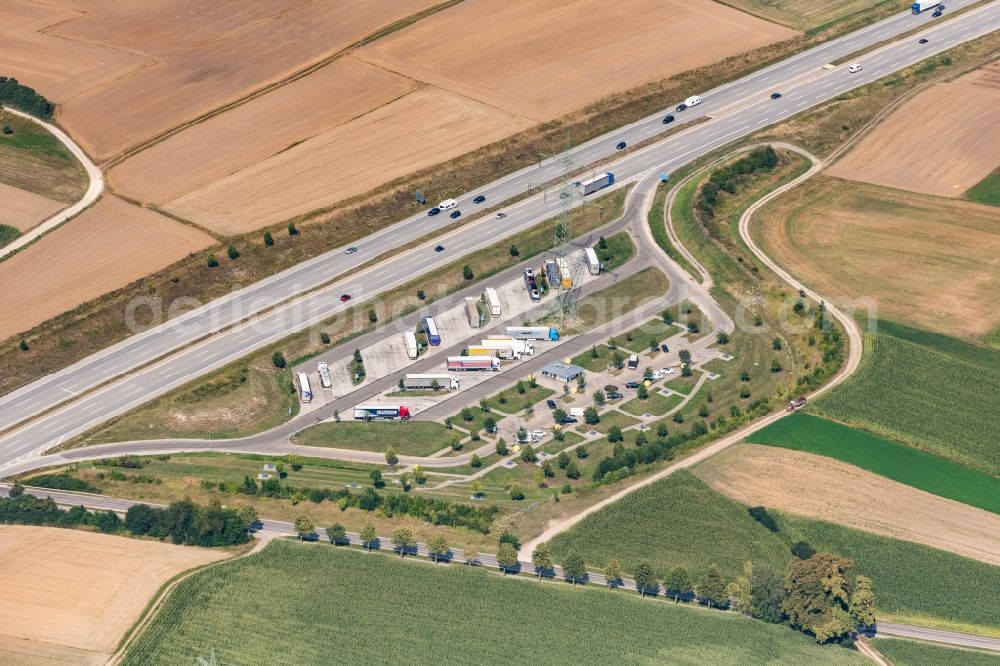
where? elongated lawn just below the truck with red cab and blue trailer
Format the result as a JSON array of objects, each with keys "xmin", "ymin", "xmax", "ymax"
[{"xmin": 292, "ymin": 420, "xmax": 452, "ymax": 456}]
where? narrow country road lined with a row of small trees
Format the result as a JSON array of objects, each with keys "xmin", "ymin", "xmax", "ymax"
[{"xmin": 0, "ymin": 483, "xmax": 1000, "ymax": 652}]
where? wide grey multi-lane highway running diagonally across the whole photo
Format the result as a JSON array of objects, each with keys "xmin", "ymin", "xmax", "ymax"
[{"xmin": 0, "ymin": 2, "xmax": 1000, "ymax": 469}]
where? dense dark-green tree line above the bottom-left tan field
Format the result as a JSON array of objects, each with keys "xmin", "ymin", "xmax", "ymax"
[{"xmin": 0, "ymin": 484, "xmax": 250, "ymax": 546}]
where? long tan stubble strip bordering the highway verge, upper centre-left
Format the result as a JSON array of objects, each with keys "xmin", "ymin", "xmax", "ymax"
[{"xmin": 166, "ymin": 88, "xmax": 530, "ymax": 234}]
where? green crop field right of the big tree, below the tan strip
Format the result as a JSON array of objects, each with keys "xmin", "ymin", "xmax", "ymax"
[{"xmin": 772, "ymin": 511, "xmax": 1000, "ymax": 637}]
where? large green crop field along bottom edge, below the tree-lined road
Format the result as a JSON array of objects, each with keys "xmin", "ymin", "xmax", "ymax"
[{"xmin": 123, "ymin": 540, "xmax": 868, "ymax": 666}]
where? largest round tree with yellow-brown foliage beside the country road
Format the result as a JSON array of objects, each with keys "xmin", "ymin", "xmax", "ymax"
[{"xmin": 781, "ymin": 553, "xmax": 860, "ymax": 643}]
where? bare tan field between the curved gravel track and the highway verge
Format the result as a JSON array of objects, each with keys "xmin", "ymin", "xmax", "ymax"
[{"xmin": 0, "ymin": 196, "xmax": 215, "ymax": 340}]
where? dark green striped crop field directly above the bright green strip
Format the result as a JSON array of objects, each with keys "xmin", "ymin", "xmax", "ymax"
[{"xmin": 808, "ymin": 333, "xmax": 1000, "ymax": 476}]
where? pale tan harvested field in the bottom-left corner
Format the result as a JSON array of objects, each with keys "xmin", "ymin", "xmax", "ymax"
[{"xmin": 0, "ymin": 525, "xmax": 227, "ymax": 665}]
